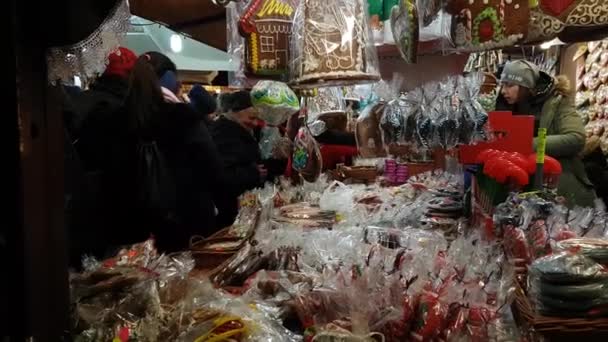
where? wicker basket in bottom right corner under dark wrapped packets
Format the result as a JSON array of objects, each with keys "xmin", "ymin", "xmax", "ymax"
[{"xmin": 513, "ymin": 282, "xmax": 608, "ymax": 342}]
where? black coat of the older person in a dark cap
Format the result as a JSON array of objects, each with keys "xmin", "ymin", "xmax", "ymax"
[{"xmin": 211, "ymin": 116, "xmax": 262, "ymax": 228}]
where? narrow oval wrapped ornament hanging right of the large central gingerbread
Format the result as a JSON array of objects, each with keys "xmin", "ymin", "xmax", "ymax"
[{"xmin": 391, "ymin": 0, "xmax": 419, "ymax": 63}]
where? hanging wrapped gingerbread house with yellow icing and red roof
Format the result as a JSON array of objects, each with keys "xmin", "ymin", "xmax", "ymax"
[{"xmin": 239, "ymin": 0, "xmax": 295, "ymax": 79}]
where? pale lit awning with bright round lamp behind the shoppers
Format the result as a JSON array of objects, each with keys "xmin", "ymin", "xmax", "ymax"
[{"xmin": 125, "ymin": 16, "xmax": 236, "ymax": 71}]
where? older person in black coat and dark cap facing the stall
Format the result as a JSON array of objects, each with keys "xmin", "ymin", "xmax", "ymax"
[{"xmin": 211, "ymin": 91, "xmax": 268, "ymax": 228}]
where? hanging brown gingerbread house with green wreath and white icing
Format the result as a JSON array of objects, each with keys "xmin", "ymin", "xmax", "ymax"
[{"xmin": 447, "ymin": 0, "xmax": 530, "ymax": 51}]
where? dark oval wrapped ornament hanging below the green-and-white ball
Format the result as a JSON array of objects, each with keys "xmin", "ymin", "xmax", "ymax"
[{"xmin": 292, "ymin": 127, "xmax": 323, "ymax": 182}]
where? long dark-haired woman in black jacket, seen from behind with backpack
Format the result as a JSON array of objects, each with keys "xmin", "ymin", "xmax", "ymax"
[{"xmin": 78, "ymin": 52, "xmax": 221, "ymax": 251}]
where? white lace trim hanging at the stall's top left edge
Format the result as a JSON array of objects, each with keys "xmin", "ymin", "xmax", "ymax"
[{"xmin": 46, "ymin": 0, "xmax": 131, "ymax": 84}]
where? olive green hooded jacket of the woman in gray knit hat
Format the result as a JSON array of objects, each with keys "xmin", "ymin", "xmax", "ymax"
[{"xmin": 496, "ymin": 72, "xmax": 595, "ymax": 207}]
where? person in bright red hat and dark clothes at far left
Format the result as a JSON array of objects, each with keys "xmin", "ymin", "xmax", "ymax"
[{"xmin": 63, "ymin": 47, "xmax": 137, "ymax": 267}]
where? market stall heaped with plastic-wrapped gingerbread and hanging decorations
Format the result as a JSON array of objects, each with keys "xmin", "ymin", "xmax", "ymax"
[{"xmin": 32, "ymin": 0, "xmax": 608, "ymax": 342}]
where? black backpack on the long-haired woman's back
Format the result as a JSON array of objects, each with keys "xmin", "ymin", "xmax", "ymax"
[{"xmin": 135, "ymin": 138, "xmax": 177, "ymax": 222}]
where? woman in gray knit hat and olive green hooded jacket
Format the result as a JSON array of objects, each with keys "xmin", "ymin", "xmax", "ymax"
[{"xmin": 496, "ymin": 60, "xmax": 595, "ymax": 207}]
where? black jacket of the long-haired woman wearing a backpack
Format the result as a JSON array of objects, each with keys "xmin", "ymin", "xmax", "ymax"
[{"xmin": 76, "ymin": 103, "xmax": 221, "ymax": 251}]
